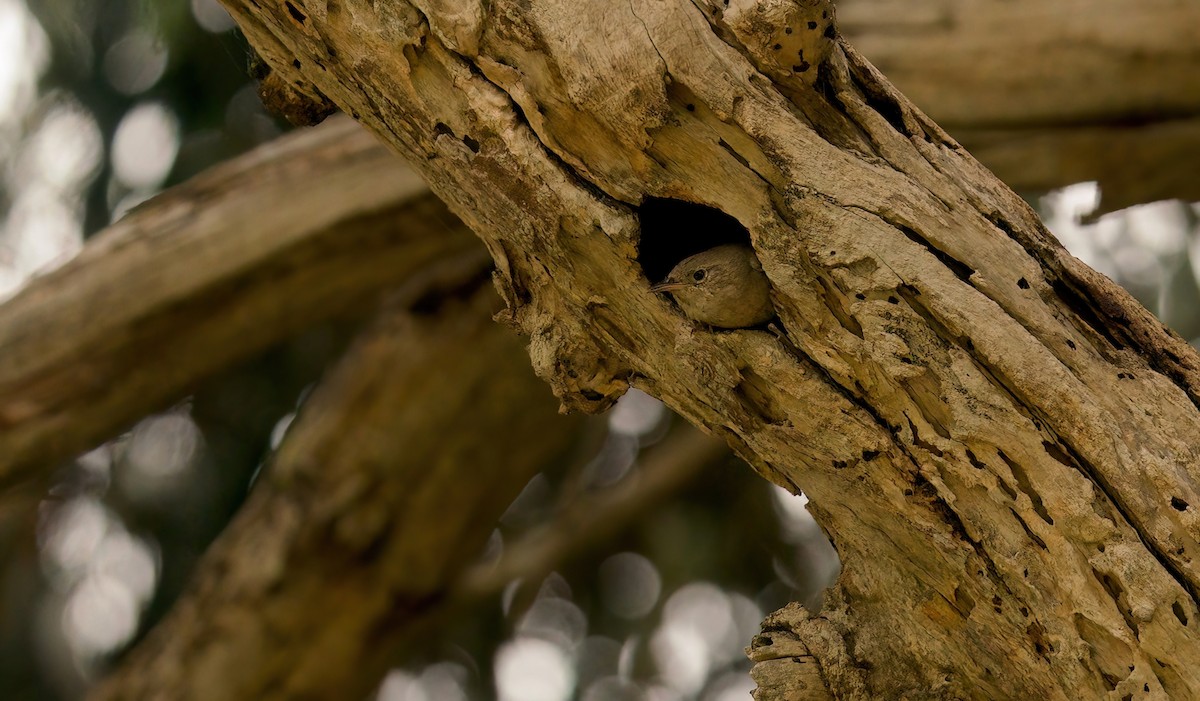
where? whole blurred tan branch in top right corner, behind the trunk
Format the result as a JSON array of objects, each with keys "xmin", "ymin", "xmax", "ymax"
[{"xmin": 838, "ymin": 0, "xmax": 1200, "ymax": 212}]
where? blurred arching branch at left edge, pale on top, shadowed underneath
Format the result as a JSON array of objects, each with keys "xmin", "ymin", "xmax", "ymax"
[{"xmin": 0, "ymin": 120, "xmax": 479, "ymax": 484}]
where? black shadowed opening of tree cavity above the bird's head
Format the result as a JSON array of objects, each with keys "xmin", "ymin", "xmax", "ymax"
[{"xmin": 637, "ymin": 197, "xmax": 750, "ymax": 282}]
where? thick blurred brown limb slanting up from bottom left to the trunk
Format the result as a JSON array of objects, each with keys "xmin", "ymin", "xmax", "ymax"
[{"xmin": 91, "ymin": 280, "xmax": 581, "ymax": 701}]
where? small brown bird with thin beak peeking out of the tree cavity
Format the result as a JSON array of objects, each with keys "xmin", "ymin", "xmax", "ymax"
[{"xmin": 650, "ymin": 244, "xmax": 775, "ymax": 329}]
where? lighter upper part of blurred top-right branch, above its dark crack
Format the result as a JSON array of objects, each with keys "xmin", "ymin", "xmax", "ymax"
[{"xmin": 838, "ymin": 0, "xmax": 1200, "ymax": 128}]
